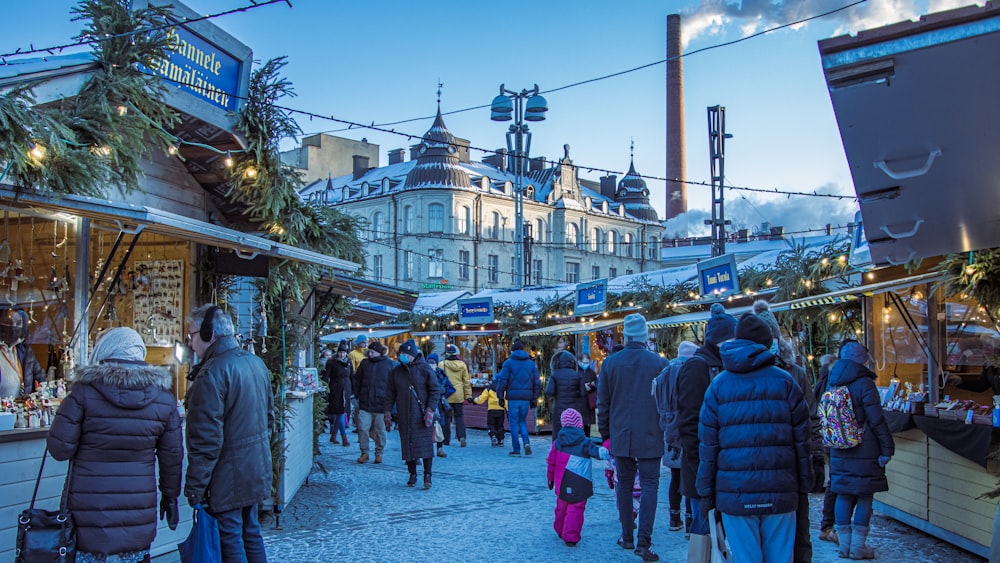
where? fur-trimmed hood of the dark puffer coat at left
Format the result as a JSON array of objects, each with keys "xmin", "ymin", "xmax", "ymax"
[{"xmin": 70, "ymin": 362, "xmax": 173, "ymax": 409}]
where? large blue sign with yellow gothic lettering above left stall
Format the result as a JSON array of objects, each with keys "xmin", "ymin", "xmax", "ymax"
[{"xmin": 148, "ymin": 27, "xmax": 242, "ymax": 111}]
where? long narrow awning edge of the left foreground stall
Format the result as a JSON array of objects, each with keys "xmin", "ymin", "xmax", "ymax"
[{"xmin": 0, "ymin": 191, "xmax": 361, "ymax": 273}]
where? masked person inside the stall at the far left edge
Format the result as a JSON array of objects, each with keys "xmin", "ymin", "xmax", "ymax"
[{"xmin": 0, "ymin": 309, "xmax": 45, "ymax": 397}]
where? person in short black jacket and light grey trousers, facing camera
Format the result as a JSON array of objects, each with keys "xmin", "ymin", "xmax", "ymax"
[{"xmin": 351, "ymin": 341, "xmax": 394, "ymax": 463}]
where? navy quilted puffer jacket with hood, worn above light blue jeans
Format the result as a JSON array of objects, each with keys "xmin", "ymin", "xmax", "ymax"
[{"xmin": 696, "ymin": 339, "xmax": 813, "ymax": 516}]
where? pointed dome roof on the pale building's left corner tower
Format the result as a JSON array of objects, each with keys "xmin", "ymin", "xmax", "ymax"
[{"xmin": 405, "ymin": 107, "xmax": 472, "ymax": 188}]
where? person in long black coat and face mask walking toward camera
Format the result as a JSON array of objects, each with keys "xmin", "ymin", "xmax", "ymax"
[{"xmin": 389, "ymin": 338, "xmax": 441, "ymax": 489}]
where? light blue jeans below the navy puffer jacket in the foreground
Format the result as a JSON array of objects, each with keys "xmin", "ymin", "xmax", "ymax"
[{"xmin": 722, "ymin": 512, "xmax": 795, "ymax": 563}]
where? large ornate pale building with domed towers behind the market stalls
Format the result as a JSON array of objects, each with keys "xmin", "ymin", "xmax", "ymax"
[{"xmin": 301, "ymin": 111, "xmax": 663, "ymax": 293}]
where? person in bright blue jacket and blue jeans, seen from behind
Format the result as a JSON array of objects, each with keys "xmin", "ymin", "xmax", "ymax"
[{"xmin": 495, "ymin": 340, "xmax": 542, "ymax": 456}]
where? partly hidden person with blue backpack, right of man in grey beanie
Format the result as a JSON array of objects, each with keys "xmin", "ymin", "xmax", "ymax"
[{"xmin": 653, "ymin": 340, "xmax": 698, "ymax": 533}]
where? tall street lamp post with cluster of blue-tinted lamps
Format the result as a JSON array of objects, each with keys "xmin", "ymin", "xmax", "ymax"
[{"xmin": 490, "ymin": 84, "xmax": 549, "ymax": 289}]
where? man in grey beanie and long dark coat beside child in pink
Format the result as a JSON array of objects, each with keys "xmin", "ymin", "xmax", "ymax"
[{"xmin": 597, "ymin": 314, "xmax": 668, "ymax": 561}]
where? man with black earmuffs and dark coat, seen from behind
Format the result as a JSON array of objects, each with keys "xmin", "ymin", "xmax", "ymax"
[{"xmin": 184, "ymin": 305, "xmax": 274, "ymax": 563}]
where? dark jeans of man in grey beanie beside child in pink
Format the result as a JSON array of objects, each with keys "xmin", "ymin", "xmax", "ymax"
[{"xmin": 615, "ymin": 457, "xmax": 660, "ymax": 547}]
